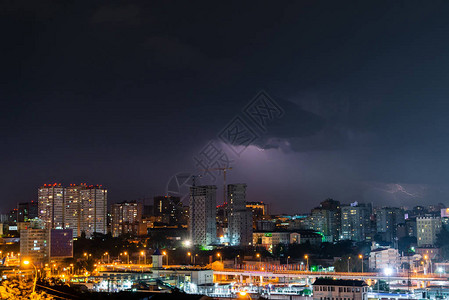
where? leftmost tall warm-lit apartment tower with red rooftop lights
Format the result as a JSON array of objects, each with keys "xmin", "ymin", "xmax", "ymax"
[{"xmin": 38, "ymin": 183, "xmax": 65, "ymax": 229}]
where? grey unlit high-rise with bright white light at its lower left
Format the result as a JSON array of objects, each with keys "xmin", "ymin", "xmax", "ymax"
[{"xmin": 189, "ymin": 185, "xmax": 217, "ymax": 246}]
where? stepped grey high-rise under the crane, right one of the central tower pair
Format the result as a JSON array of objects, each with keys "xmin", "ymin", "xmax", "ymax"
[{"xmin": 227, "ymin": 183, "xmax": 253, "ymax": 246}]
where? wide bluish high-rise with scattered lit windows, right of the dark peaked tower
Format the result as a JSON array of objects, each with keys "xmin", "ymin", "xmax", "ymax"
[{"xmin": 340, "ymin": 202, "xmax": 372, "ymax": 242}]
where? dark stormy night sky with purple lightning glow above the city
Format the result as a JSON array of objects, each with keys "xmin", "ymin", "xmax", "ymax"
[{"xmin": 0, "ymin": 0, "xmax": 449, "ymax": 213}]
